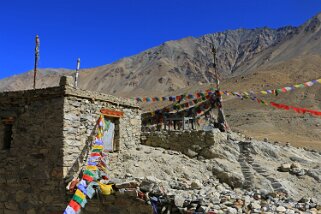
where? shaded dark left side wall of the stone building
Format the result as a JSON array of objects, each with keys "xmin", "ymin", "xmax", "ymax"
[{"xmin": 0, "ymin": 93, "xmax": 65, "ymax": 214}]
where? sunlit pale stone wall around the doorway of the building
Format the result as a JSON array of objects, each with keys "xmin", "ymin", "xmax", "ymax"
[{"xmin": 63, "ymin": 89, "xmax": 141, "ymax": 182}]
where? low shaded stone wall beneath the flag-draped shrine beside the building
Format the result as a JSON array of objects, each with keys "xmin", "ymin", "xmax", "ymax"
[{"xmin": 142, "ymin": 129, "xmax": 227, "ymax": 158}]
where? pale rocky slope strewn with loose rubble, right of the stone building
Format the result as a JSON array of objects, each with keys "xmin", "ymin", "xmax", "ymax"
[{"xmin": 105, "ymin": 130, "xmax": 321, "ymax": 213}]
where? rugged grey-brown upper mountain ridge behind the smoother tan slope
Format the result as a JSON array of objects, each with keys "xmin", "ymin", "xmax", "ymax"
[{"xmin": 0, "ymin": 15, "xmax": 321, "ymax": 96}]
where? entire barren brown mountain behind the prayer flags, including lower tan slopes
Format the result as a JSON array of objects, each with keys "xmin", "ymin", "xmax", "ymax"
[{"xmin": 0, "ymin": 14, "xmax": 321, "ymax": 150}]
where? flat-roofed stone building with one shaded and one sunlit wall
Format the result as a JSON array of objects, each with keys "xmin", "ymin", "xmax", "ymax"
[{"xmin": 0, "ymin": 77, "xmax": 141, "ymax": 214}]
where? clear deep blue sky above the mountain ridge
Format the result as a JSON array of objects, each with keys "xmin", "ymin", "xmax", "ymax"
[{"xmin": 0, "ymin": 0, "xmax": 321, "ymax": 78}]
